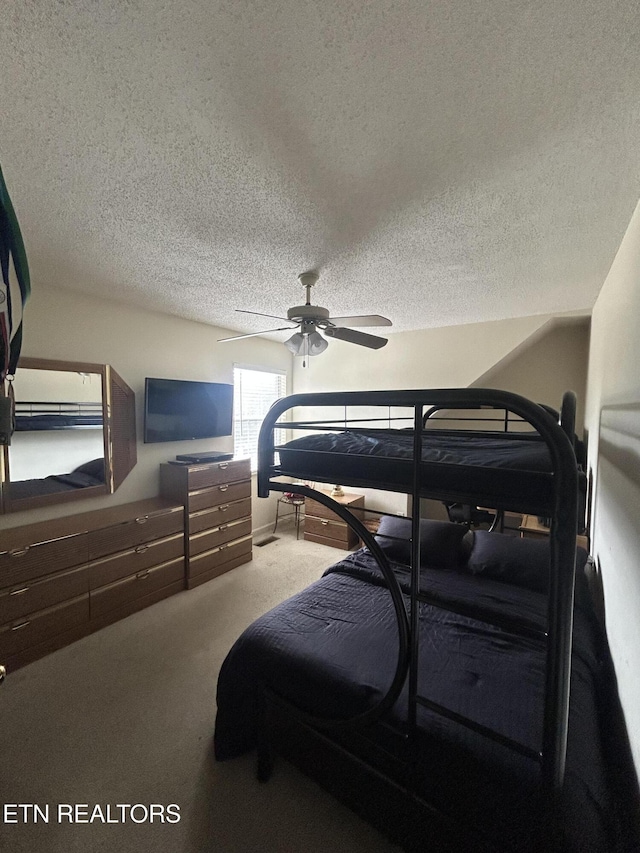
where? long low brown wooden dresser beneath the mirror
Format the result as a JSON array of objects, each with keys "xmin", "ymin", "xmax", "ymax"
[{"xmin": 0, "ymin": 498, "xmax": 185, "ymax": 671}]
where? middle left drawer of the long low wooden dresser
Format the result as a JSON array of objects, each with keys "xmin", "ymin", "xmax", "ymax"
[{"xmin": 0, "ymin": 566, "xmax": 89, "ymax": 625}]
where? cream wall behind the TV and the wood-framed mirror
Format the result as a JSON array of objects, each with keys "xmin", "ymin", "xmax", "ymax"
[{"xmin": 0, "ymin": 282, "xmax": 291, "ymax": 530}]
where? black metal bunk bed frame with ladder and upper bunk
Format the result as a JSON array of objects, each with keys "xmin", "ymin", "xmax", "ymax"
[{"xmin": 218, "ymin": 389, "xmax": 608, "ymax": 851}]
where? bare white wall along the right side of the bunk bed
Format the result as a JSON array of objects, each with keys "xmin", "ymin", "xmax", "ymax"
[{"xmin": 585, "ymin": 198, "xmax": 640, "ymax": 770}]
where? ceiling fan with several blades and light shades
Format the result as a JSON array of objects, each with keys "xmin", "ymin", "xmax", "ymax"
[{"xmin": 219, "ymin": 272, "xmax": 392, "ymax": 356}]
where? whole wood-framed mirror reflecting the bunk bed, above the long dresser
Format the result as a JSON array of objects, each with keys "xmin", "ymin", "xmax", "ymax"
[{"xmin": 2, "ymin": 358, "xmax": 136, "ymax": 512}]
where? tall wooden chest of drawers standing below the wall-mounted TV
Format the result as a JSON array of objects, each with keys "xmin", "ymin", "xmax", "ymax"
[{"xmin": 160, "ymin": 459, "xmax": 253, "ymax": 589}]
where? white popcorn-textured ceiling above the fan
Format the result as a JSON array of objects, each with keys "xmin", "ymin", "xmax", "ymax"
[{"xmin": 0, "ymin": 0, "xmax": 640, "ymax": 336}]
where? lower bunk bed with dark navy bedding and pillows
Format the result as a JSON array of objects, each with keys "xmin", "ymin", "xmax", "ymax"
[{"xmin": 215, "ymin": 516, "xmax": 616, "ymax": 853}]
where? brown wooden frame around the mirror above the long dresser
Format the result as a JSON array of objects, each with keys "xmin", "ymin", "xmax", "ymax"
[{"xmin": 0, "ymin": 356, "xmax": 137, "ymax": 513}]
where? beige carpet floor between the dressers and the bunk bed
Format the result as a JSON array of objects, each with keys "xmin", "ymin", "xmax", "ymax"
[{"xmin": 0, "ymin": 524, "xmax": 398, "ymax": 853}]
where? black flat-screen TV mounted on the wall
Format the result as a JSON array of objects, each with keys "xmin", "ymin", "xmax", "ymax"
[{"xmin": 144, "ymin": 377, "xmax": 233, "ymax": 444}]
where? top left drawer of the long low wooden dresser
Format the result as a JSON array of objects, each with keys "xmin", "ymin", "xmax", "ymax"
[{"xmin": 0, "ymin": 533, "xmax": 88, "ymax": 587}]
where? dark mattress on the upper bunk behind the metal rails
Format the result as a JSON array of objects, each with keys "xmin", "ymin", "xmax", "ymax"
[{"xmin": 277, "ymin": 429, "xmax": 585, "ymax": 515}]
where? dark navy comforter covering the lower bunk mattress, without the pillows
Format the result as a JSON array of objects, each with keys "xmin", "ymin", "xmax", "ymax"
[{"xmin": 215, "ymin": 534, "xmax": 610, "ymax": 853}]
